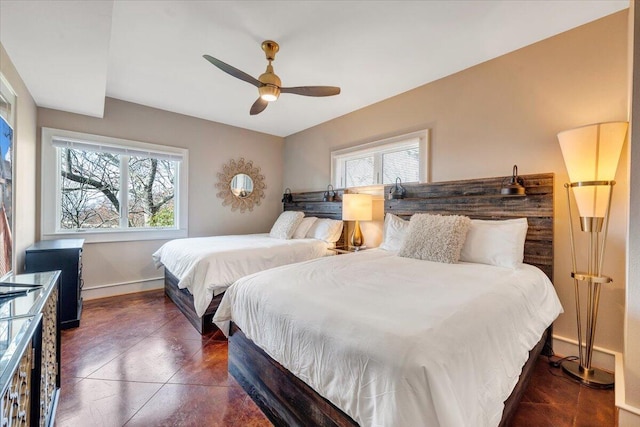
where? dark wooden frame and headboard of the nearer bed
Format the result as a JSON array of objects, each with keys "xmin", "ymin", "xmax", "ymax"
[{"xmin": 229, "ymin": 174, "xmax": 554, "ymax": 426}]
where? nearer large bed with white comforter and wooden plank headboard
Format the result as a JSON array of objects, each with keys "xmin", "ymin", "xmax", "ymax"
[{"xmin": 214, "ymin": 174, "xmax": 562, "ymax": 426}]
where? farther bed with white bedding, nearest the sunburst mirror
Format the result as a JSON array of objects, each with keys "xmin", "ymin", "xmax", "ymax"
[{"xmin": 153, "ymin": 191, "xmax": 344, "ymax": 334}]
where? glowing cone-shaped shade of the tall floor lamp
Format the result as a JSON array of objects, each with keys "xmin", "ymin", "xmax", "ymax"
[{"xmin": 558, "ymin": 122, "xmax": 629, "ymax": 218}]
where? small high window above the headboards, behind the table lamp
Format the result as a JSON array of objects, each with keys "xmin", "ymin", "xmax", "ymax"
[{"xmin": 331, "ymin": 130, "xmax": 428, "ymax": 188}]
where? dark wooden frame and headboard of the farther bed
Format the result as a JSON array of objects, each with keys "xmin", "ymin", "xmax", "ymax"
[{"xmin": 164, "ymin": 190, "xmax": 346, "ymax": 335}]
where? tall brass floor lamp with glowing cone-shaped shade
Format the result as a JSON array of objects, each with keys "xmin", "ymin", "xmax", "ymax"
[{"xmin": 558, "ymin": 122, "xmax": 628, "ymax": 388}]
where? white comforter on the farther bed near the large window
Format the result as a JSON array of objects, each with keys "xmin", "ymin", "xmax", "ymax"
[{"xmin": 152, "ymin": 234, "xmax": 328, "ymax": 316}]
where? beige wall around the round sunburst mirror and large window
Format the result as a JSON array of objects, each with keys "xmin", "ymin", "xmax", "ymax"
[{"xmin": 38, "ymin": 98, "xmax": 283, "ymax": 293}]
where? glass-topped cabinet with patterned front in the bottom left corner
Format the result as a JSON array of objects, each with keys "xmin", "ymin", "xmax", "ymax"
[{"xmin": 0, "ymin": 271, "xmax": 60, "ymax": 426}]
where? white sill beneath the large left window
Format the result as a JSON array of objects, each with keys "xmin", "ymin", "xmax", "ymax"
[{"xmin": 42, "ymin": 230, "xmax": 188, "ymax": 243}]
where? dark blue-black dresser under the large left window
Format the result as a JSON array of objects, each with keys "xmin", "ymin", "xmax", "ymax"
[{"xmin": 25, "ymin": 239, "xmax": 84, "ymax": 329}]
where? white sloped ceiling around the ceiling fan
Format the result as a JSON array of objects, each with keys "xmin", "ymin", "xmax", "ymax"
[{"xmin": 0, "ymin": 0, "xmax": 629, "ymax": 136}]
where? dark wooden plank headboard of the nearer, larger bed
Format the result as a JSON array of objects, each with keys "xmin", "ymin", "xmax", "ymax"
[{"xmin": 384, "ymin": 173, "xmax": 554, "ymax": 281}]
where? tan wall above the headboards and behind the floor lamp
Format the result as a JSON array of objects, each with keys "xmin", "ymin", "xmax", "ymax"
[{"xmin": 284, "ymin": 11, "xmax": 628, "ymax": 351}]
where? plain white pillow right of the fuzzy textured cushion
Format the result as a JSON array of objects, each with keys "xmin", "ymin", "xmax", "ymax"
[{"xmin": 460, "ymin": 218, "xmax": 529, "ymax": 268}]
